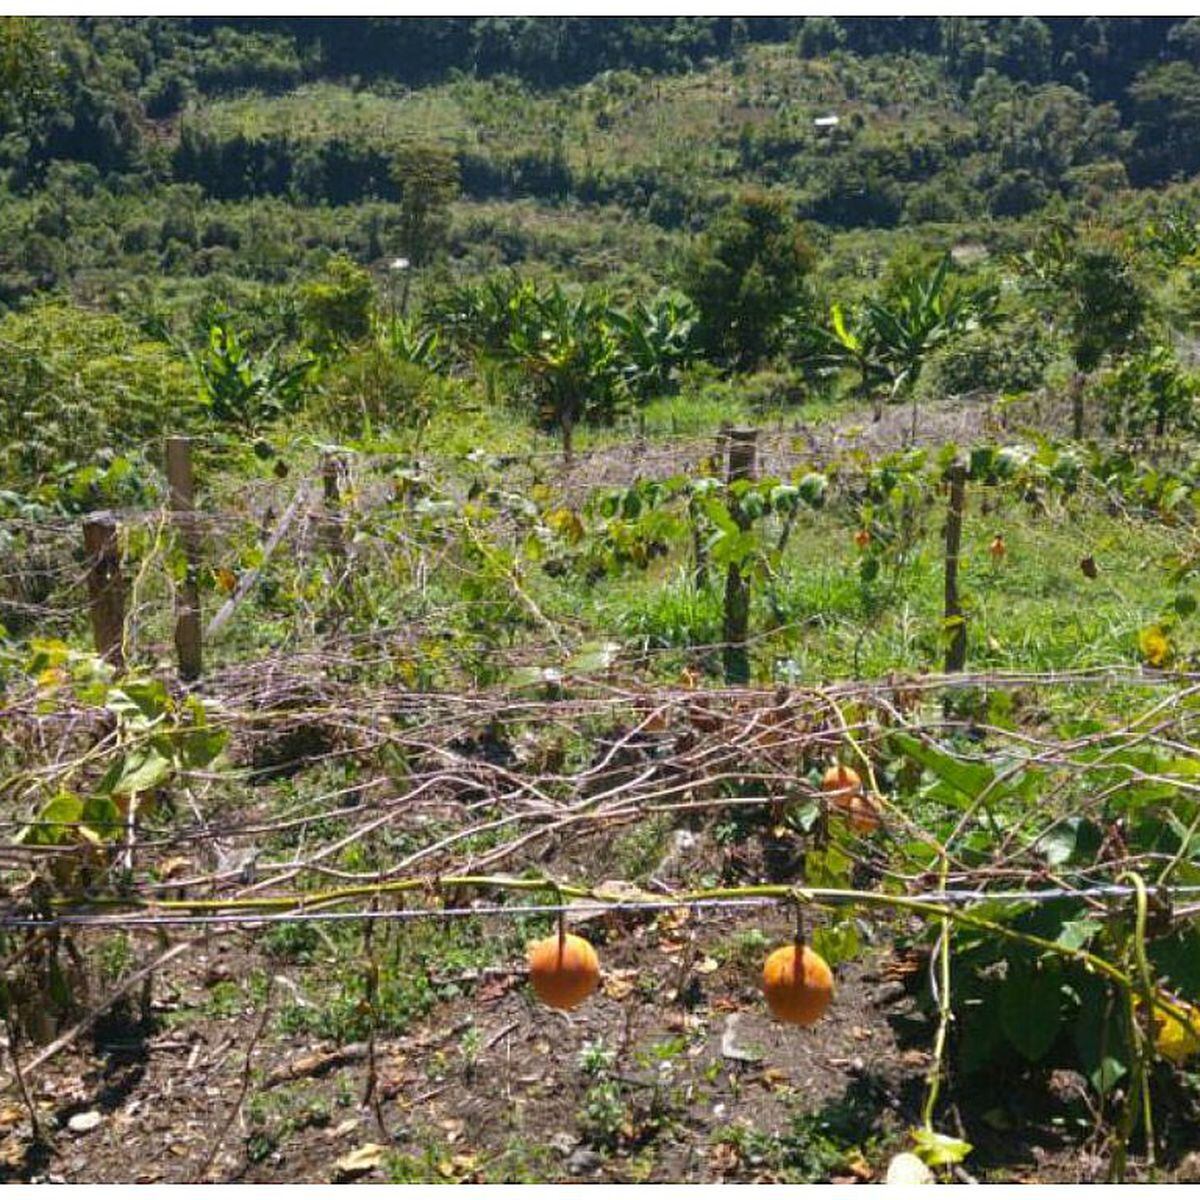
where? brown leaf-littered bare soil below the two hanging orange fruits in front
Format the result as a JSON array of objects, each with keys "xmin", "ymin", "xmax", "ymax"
[{"xmin": 0, "ymin": 897, "xmax": 1180, "ymax": 1183}]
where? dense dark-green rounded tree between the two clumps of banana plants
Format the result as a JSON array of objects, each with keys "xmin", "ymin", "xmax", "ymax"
[{"xmin": 683, "ymin": 190, "xmax": 814, "ymax": 367}]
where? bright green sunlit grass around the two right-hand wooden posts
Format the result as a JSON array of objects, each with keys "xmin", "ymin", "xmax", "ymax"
[{"xmin": 576, "ymin": 487, "xmax": 1195, "ymax": 683}]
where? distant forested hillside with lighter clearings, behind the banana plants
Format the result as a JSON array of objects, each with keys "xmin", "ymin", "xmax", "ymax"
[{"xmin": 0, "ymin": 18, "xmax": 1200, "ymax": 301}]
